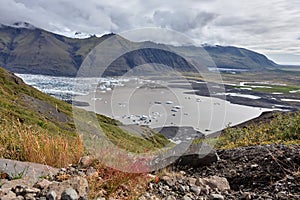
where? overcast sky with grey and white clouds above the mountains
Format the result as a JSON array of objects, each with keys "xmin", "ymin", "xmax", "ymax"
[{"xmin": 0, "ymin": 0, "xmax": 300, "ymax": 64}]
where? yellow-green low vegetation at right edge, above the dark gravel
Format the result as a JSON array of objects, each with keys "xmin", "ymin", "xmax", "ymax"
[{"xmin": 215, "ymin": 111, "xmax": 300, "ymax": 149}]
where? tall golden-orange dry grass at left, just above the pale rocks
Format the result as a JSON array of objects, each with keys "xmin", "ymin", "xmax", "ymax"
[{"xmin": 0, "ymin": 119, "xmax": 83, "ymax": 167}]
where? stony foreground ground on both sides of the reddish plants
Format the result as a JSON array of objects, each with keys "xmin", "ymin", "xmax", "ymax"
[{"xmin": 0, "ymin": 145, "xmax": 300, "ymax": 200}]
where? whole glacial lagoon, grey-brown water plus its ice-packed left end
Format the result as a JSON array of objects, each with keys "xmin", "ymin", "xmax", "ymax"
[{"xmin": 19, "ymin": 74, "xmax": 271, "ymax": 134}]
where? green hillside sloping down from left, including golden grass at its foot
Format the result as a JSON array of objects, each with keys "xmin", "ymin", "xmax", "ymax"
[{"xmin": 0, "ymin": 68, "xmax": 169, "ymax": 167}]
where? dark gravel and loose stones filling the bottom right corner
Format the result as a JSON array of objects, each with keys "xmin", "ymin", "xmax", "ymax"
[{"xmin": 140, "ymin": 145, "xmax": 300, "ymax": 200}]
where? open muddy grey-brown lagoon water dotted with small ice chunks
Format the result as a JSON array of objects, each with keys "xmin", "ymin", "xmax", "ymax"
[{"xmin": 75, "ymin": 80, "xmax": 271, "ymax": 134}]
